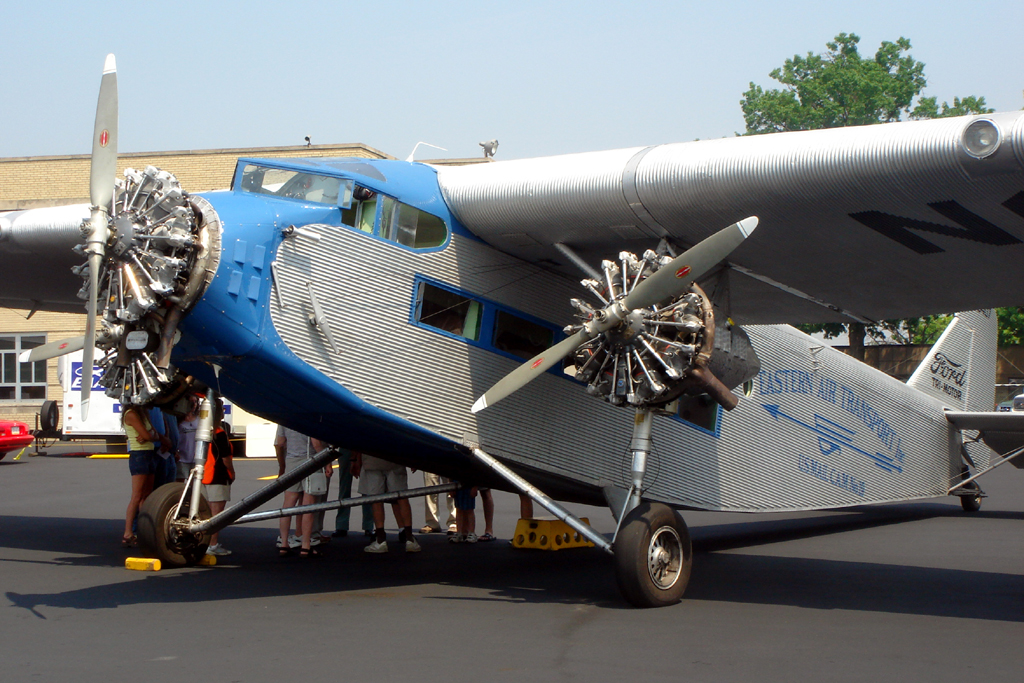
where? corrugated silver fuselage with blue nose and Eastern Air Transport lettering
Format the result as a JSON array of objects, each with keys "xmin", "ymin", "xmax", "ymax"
[{"xmin": 178, "ymin": 176, "xmax": 959, "ymax": 512}]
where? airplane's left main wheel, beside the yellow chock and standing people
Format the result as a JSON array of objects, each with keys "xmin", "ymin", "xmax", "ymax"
[{"xmin": 138, "ymin": 481, "xmax": 211, "ymax": 566}]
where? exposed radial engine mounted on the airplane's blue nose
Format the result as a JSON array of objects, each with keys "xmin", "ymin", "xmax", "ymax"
[{"xmin": 73, "ymin": 166, "xmax": 221, "ymax": 404}]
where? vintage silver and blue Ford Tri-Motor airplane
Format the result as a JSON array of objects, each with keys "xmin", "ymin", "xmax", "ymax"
[{"xmin": 0, "ymin": 55, "xmax": 1024, "ymax": 606}]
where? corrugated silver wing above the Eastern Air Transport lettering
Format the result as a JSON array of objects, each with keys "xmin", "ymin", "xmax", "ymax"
[{"xmin": 437, "ymin": 112, "xmax": 1024, "ymax": 324}]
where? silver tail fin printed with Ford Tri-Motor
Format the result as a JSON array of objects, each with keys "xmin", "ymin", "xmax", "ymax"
[{"xmin": 906, "ymin": 309, "xmax": 997, "ymax": 411}]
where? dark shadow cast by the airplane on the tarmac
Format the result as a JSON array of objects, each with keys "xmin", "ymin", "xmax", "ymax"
[{"xmin": 0, "ymin": 505, "xmax": 1024, "ymax": 622}]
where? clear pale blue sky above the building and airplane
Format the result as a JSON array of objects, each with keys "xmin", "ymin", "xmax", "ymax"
[{"xmin": 0, "ymin": 0, "xmax": 1024, "ymax": 161}]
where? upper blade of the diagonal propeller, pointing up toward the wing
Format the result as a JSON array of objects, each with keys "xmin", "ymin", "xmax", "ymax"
[{"xmin": 623, "ymin": 216, "xmax": 758, "ymax": 310}]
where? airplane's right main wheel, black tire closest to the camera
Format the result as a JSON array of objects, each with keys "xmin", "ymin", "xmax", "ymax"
[{"xmin": 614, "ymin": 503, "xmax": 693, "ymax": 607}]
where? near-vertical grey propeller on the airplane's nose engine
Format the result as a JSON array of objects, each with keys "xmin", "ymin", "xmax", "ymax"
[{"xmin": 82, "ymin": 54, "xmax": 118, "ymax": 420}]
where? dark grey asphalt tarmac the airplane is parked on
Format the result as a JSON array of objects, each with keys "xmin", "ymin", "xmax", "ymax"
[{"xmin": 0, "ymin": 457, "xmax": 1024, "ymax": 683}]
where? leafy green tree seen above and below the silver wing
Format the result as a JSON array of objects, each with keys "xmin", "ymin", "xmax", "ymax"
[{"xmin": 739, "ymin": 33, "xmax": 995, "ymax": 360}]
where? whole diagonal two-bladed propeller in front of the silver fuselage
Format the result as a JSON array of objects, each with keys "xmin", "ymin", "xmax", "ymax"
[{"xmin": 471, "ymin": 216, "xmax": 758, "ymax": 413}]
